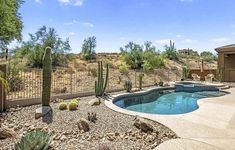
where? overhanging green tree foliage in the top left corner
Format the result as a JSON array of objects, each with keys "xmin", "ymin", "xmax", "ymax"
[{"xmin": 0, "ymin": 0, "xmax": 23, "ymax": 57}]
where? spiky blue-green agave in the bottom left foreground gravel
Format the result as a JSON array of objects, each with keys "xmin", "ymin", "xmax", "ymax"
[{"xmin": 15, "ymin": 130, "xmax": 51, "ymax": 150}]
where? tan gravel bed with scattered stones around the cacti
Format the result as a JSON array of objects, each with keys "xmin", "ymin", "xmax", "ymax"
[{"xmin": 0, "ymin": 97, "xmax": 178, "ymax": 150}]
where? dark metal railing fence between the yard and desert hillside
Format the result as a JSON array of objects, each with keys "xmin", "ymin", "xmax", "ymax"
[{"xmin": 6, "ymin": 68, "xmax": 182, "ymax": 101}]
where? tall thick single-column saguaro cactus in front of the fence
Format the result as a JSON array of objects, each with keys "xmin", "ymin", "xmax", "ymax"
[{"xmin": 42, "ymin": 47, "xmax": 52, "ymax": 106}]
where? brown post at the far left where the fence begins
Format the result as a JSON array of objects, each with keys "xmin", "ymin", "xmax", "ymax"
[{"xmin": 0, "ymin": 64, "xmax": 7, "ymax": 112}]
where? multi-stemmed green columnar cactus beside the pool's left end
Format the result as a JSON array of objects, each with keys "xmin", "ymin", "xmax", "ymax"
[{"xmin": 95, "ymin": 61, "xmax": 109, "ymax": 97}]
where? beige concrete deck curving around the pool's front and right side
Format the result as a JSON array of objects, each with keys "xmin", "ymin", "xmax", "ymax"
[{"xmin": 105, "ymin": 88, "xmax": 235, "ymax": 150}]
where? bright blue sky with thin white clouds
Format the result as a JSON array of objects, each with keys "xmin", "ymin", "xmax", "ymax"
[{"xmin": 16, "ymin": 0, "xmax": 235, "ymax": 53}]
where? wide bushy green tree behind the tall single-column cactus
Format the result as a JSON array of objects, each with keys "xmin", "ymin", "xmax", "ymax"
[{"xmin": 16, "ymin": 26, "xmax": 71, "ymax": 68}]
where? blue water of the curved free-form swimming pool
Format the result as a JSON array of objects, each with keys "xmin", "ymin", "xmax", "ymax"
[{"xmin": 114, "ymin": 91, "xmax": 228, "ymax": 114}]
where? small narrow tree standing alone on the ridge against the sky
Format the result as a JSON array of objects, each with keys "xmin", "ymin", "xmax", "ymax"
[{"xmin": 82, "ymin": 36, "xmax": 96, "ymax": 61}]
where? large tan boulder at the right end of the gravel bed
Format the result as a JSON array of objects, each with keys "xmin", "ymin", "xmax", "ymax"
[{"xmin": 134, "ymin": 116, "xmax": 155, "ymax": 132}]
